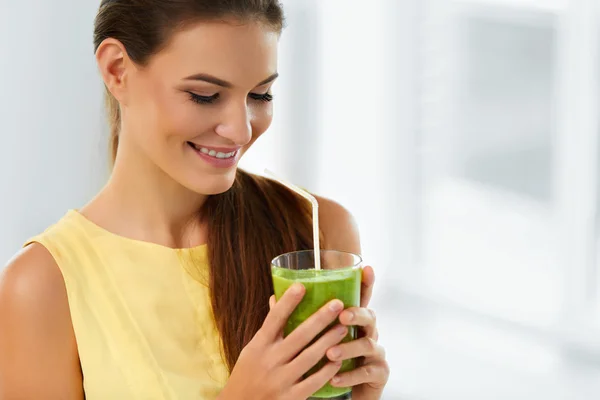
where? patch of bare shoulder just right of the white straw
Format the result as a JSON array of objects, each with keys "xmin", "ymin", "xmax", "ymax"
[{"xmin": 315, "ymin": 196, "xmax": 361, "ymax": 254}]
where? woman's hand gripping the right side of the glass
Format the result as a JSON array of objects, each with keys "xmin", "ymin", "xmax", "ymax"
[{"xmin": 327, "ymin": 267, "xmax": 390, "ymax": 400}]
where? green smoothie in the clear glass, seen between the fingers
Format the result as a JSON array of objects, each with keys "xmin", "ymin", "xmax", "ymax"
[{"xmin": 272, "ymin": 266, "xmax": 361, "ymax": 398}]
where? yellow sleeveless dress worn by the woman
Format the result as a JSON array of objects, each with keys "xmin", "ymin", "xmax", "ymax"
[{"xmin": 27, "ymin": 211, "xmax": 228, "ymax": 400}]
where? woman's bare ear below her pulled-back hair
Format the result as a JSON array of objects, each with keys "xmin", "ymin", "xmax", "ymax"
[{"xmin": 96, "ymin": 38, "xmax": 133, "ymax": 104}]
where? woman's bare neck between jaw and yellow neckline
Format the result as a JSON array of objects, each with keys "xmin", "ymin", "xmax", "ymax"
[{"xmin": 82, "ymin": 136, "xmax": 208, "ymax": 248}]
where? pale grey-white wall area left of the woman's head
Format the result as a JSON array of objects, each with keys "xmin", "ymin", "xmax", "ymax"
[{"xmin": 0, "ymin": 0, "xmax": 108, "ymax": 264}]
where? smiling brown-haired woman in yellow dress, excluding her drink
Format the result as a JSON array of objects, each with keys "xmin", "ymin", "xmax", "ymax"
[{"xmin": 0, "ymin": 0, "xmax": 388, "ymax": 400}]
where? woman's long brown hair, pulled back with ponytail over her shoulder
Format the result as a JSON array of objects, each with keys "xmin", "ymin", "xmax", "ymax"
[{"xmin": 94, "ymin": 0, "xmax": 313, "ymax": 370}]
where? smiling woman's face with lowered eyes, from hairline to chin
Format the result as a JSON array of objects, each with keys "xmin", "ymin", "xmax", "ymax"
[{"xmin": 120, "ymin": 22, "xmax": 279, "ymax": 195}]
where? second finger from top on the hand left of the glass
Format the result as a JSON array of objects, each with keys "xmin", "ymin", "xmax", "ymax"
[{"xmin": 280, "ymin": 300, "xmax": 344, "ymax": 360}]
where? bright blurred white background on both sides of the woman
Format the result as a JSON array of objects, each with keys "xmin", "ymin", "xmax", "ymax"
[{"xmin": 0, "ymin": 0, "xmax": 600, "ymax": 400}]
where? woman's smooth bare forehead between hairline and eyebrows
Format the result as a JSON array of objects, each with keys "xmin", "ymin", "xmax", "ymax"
[{"xmin": 148, "ymin": 22, "xmax": 279, "ymax": 86}]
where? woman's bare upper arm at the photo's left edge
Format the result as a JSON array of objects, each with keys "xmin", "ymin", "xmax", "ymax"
[{"xmin": 0, "ymin": 244, "xmax": 84, "ymax": 400}]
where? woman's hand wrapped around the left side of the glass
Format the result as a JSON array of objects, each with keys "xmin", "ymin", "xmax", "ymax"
[{"xmin": 218, "ymin": 283, "xmax": 348, "ymax": 400}]
